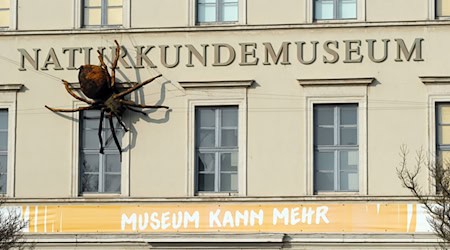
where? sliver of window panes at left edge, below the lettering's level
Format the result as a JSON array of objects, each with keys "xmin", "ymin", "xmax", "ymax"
[{"xmin": 0, "ymin": 109, "xmax": 8, "ymax": 194}]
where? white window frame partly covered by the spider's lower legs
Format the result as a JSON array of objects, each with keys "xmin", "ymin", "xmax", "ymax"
[{"xmin": 71, "ymin": 101, "xmax": 131, "ymax": 198}]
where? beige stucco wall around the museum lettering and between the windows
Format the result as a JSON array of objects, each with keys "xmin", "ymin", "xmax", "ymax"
[{"xmin": 0, "ymin": 25, "xmax": 442, "ymax": 198}]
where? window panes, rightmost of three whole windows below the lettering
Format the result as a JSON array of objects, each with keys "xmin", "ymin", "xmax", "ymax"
[{"xmin": 313, "ymin": 104, "xmax": 359, "ymax": 192}]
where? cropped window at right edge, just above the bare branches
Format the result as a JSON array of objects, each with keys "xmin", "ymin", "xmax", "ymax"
[{"xmin": 436, "ymin": 103, "xmax": 450, "ymax": 165}]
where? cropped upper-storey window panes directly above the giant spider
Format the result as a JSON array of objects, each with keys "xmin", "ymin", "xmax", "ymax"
[{"xmin": 83, "ymin": 0, "xmax": 123, "ymax": 27}]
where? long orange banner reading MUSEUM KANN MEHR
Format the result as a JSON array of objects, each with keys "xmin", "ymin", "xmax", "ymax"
[{"xmin": 21, "ymin": 203, "xmax": 417, "ymax": 233}]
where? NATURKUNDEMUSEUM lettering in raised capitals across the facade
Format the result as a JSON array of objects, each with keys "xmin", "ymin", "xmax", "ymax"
[{"xmin": 18, "ymin": 38, "xmax": 424, "ymax": 71}]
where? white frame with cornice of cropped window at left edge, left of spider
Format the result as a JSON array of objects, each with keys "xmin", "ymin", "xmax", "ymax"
[{"xmin": 0, "ymin": 84, "xmax": 23, "ymax": 197}]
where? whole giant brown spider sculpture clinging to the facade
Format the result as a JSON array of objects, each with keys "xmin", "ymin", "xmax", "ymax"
[{"xmin": 45, "ymin": 40, "xmax": 169, "ymax": 155}]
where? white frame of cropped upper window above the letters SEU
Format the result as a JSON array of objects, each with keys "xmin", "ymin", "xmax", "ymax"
[{"xmin": 305, "ymin": 0, "xmax": 366, "ymax": 23}]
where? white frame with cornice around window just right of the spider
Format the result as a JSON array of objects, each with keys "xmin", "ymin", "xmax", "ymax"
[{"xmin": 179, "ymin": 80, "xmax": 254, "ymax": 197}]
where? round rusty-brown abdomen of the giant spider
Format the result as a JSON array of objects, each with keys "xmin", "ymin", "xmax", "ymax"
[{"xmin": 78, "ymin": 65, "xmax": 113, "ymax": 100}]
